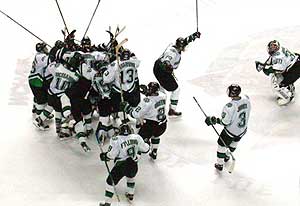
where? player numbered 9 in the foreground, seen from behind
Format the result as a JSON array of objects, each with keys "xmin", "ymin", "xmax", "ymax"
[{"xmin": 100, "ymin": 124, "xmax": 150, "ymax": 206}]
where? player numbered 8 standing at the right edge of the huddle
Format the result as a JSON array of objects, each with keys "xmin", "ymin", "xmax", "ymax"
[{"xmin": 121, "ymin": 82, "xmax": 167, "ymax": 160}]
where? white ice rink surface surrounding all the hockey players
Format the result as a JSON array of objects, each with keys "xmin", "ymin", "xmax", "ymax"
[{"xmin": 0, "ymin": 0, "xmax": 300, "ymax": 206}]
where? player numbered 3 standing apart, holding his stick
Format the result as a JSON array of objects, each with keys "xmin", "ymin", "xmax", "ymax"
[{"xmin": 205, "ymin": 84, "xmax": 251, "ymax": 171}]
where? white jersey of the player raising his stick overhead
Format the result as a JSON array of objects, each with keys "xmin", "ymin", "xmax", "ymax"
[{"xmin": 159, "ymin": 45, "xmax": 181, "ymax": 69}]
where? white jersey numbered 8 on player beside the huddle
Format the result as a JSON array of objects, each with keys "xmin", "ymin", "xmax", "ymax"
[{"xmin": 131, "ymin": 92, "xmax": 167, "ymax": 122}]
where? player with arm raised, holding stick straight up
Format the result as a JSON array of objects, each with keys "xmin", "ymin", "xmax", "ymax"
[{"xmin": 153, "ymin": 32, "xmax": 201, "ymax": 116}]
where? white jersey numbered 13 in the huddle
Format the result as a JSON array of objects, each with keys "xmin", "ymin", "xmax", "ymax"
[{"xmin": 103, "ymin": 57, "xmax": 140, "ymax": 92}]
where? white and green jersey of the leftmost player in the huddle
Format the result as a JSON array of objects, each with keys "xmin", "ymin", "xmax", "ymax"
[{"xmin": 28, "ymin": 52, "xmax": 48, "ymax": 87}]
